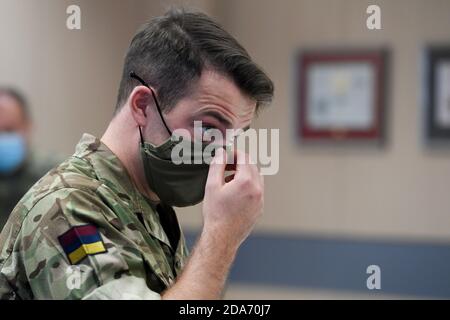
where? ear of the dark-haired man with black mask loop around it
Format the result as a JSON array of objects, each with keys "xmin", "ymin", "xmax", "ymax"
[{"xmin": 128, "ymin": 86, "xmax": 154, "ymax": 127}]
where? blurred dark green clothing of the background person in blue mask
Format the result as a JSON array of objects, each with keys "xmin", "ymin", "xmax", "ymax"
[{"xmin": 0, "ymin": 155, "xmax": 56, "ymax": 231}]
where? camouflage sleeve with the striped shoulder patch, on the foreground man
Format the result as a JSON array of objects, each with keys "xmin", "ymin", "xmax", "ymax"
[{"xmin": 18, "ymin": 188, "xmax": 160, "ymax": 299}]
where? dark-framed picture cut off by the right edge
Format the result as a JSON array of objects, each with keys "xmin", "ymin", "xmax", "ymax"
[{"xmin": 424, "ymin": 46, "xmax": 450, "ymax": 145}]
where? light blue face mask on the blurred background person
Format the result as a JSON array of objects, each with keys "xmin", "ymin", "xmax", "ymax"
[{"xmin": 0, "ymin": 133, "xmax": 26, "ymax": 174}]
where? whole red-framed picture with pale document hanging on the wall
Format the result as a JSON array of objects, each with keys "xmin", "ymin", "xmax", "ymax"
[{"xmin": 298, "ymin": 50, "xmax": 387, "ymax": 144}]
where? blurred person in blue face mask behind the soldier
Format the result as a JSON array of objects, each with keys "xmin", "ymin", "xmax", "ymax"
[{"xmin": 0, "ymin": 87, "xmax": 56, "ymax": 230}]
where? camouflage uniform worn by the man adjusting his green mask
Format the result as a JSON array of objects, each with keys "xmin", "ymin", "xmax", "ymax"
[{"xmin": 0, "ymin": 134, "xmax": 188, "ymax": 299}]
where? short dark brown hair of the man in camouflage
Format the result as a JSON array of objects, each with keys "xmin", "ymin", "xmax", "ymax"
[{"xmin": 116, "ymin": 9, "xmax": 274, "ymax": 111}]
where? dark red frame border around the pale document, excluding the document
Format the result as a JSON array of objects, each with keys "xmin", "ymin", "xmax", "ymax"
[{"xmin": 298, "ymin": 50, "xmax": 387, "ymax": 143}]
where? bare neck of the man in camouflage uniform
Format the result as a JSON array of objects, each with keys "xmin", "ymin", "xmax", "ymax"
[{"xmin": 101, "ymin": 114, "xmax": 159, "ymax": 202}]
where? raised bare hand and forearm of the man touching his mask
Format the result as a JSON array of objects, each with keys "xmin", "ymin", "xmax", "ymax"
[{"xmin": 162, "ymin": 149, "xmax": 264, "ymax": 299}]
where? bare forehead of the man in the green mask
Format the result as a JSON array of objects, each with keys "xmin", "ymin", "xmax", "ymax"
[{"xmin": 194, "ymin": 71, "xmax": 256, "ymax": 123}]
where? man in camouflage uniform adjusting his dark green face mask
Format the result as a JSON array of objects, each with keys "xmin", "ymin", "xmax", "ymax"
[{"xmin": 0, "ymin": 10, "xmax": 273, "ymax": 299}]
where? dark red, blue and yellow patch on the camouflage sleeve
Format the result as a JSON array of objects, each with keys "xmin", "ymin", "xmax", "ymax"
[{"xmin": 58, "ymin": 224, "xmax": 107, "ymax": 264}]
